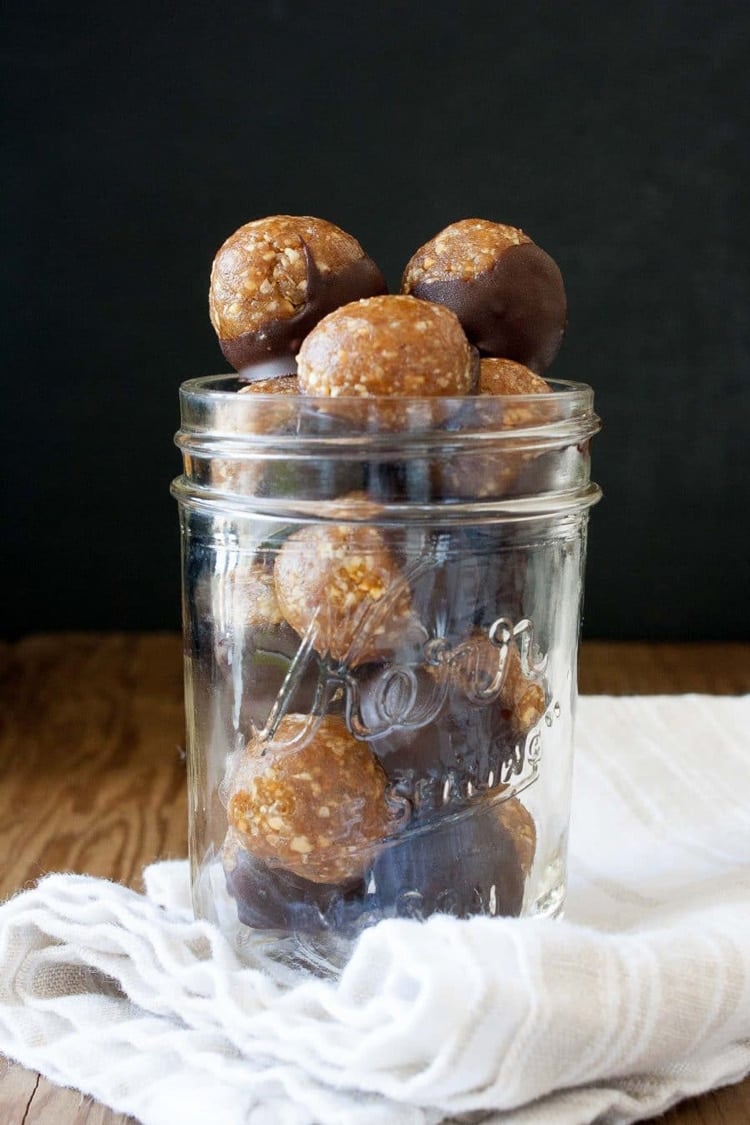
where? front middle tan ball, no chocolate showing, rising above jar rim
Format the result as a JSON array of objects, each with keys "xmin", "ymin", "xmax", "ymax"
[{"xmin": 297, "ymin": 296, "xmax": 479, "ymax": 397}]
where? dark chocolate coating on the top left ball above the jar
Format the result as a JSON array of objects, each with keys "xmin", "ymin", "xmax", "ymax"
[{"xmin": 219, "ymin": 239, "xmax": 388, "ymax": 371}]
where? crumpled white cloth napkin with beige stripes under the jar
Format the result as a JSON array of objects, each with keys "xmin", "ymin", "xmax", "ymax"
[{"xmin": 0, "ymin": 695, "xmax": 750, "ymax": 1125}]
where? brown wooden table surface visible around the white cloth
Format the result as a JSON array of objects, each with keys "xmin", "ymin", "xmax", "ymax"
[{"xmin": 0, "ymin": 633, "xmax": 750, "ymax": 1125}]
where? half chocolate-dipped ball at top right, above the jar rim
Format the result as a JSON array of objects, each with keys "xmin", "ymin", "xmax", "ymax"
[{"xmin": 401, "ymin": 218, "xmax": 568, "ymax": 374}]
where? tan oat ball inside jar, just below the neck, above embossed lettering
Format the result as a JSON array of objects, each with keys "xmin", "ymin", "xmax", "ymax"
[{"xmin": 274, "ymin": 524, "xmax": 418, "ymax": 666}]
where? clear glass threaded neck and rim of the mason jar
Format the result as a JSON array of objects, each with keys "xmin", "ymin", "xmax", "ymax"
[{"xmin": 174, "ymin": 375, "xmax": 600, "ymax": 519}]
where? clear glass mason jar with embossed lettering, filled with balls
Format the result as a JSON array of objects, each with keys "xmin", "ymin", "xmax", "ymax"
[{"xmin": 173, "ymin": 376, "xmax": 599, "ymax": 969}]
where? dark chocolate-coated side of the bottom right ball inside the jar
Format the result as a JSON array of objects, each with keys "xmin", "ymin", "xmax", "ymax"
[{"xmin": 370, "ymin": 802, "xmax": 527, "ymax": 918}]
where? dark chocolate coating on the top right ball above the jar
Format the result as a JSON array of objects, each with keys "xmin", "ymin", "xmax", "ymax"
[{"xmin": 409, "ymin": 242, "xmax": 568, "ymax": 375}]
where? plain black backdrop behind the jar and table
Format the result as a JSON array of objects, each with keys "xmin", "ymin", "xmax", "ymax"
[{"xmin": 0, "ymin": 0, "xmax": 750, "ymax": 639}]
